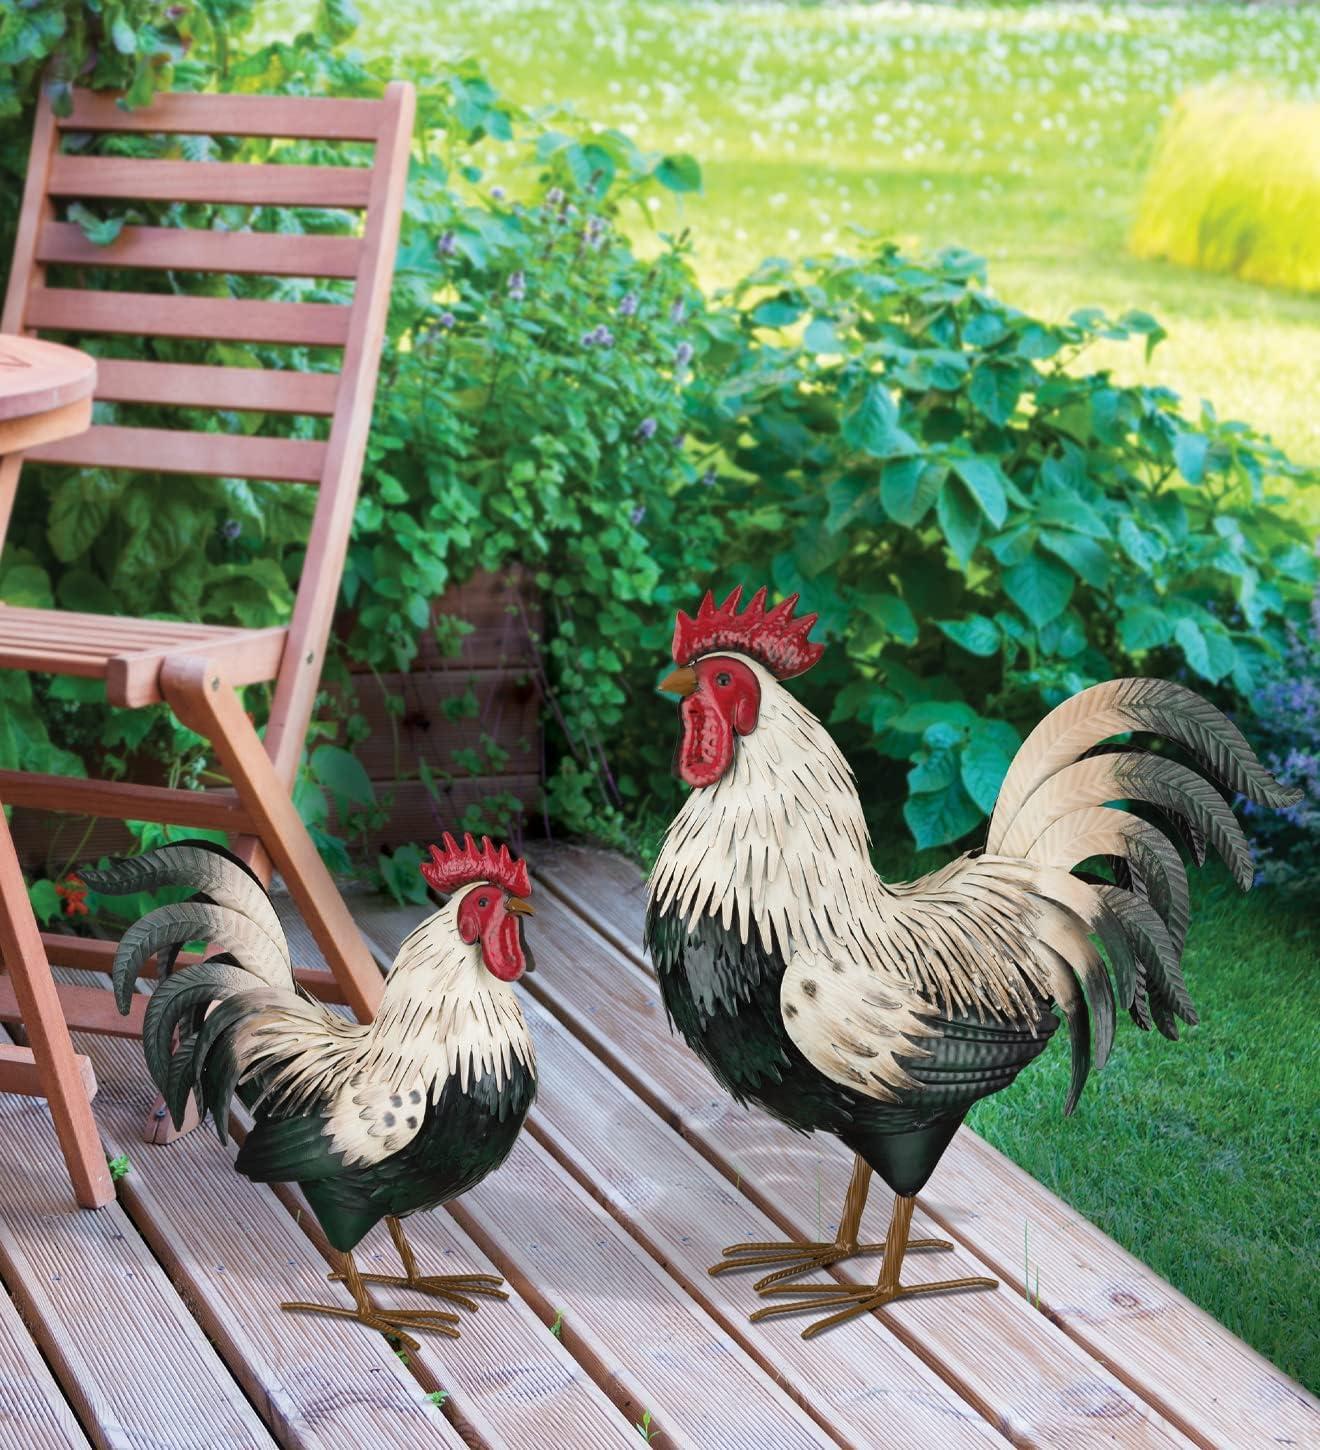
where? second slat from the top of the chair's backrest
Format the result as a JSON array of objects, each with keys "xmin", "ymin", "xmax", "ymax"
[{"xmin": 46, "ymin": 155, "xmax": 371, "ymax": 207}]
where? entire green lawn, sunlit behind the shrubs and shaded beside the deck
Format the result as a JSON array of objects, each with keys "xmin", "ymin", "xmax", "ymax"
[{"xmin": 267, "ymin": 0, "xmax": 1320, "ymax": 1386}]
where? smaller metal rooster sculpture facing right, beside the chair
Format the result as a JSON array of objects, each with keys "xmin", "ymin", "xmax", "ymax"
[{"xmin": 81, "ymin": 835, "xmax": 537, "ymax": 1349}]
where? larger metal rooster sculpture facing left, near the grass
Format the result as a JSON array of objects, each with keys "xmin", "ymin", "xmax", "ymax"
[{"xmin": 645, "ymin": 589, "xmax": 1295, "ymax": 1335}]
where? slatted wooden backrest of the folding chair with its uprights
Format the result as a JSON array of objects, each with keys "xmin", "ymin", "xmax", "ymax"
[{"xmin": 0, "ymin": 81, "xmax": 415, "ymax": 783}]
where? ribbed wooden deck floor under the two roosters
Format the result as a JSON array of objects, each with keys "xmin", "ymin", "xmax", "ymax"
[{"xmin": 0, "ymin": 847, "xmax": 1320, "ymax": 1450}]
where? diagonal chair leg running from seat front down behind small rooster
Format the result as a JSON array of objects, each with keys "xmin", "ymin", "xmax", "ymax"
[{"xmin": 161, "ymin": 655, "xmax": 383, "ymax": 1022}]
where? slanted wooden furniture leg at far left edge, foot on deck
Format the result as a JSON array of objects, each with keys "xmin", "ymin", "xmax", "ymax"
[{"xmin": 0, "ymin": 811, "xmax": 115, "ymax": 1208}]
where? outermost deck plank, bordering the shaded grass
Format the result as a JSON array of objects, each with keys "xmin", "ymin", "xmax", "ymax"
[{"xmin": 537, "ymin": 845, "xmax": 1320, "ymax": 1450}]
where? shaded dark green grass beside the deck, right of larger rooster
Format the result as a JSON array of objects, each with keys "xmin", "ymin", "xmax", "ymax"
[{"xmin": 970, "ymin": 871, "xmax": 1320, "ymax": 1389}]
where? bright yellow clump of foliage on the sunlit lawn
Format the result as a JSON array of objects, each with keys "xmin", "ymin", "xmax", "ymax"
[{"xmin": 1129, "ymin": 87, "xmax": 1320, "ymax": 291}]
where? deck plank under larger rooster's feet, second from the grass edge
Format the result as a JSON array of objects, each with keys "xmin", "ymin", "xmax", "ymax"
[{"xmin": 374, "ymin": 893, "xmax": 1206, "ymax": 1446}]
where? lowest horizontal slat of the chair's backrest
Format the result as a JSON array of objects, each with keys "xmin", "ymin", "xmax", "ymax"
[{"xmin": 28, "ymin": 423, "xmax": 326, "ymax": 483}]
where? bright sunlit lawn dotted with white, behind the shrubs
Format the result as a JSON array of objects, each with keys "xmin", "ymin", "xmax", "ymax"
[{"xmin": 300, "ymin": 0, "xmax": 1320, "ymax": 461}]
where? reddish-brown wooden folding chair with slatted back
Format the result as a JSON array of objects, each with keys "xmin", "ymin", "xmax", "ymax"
[{"xmin": 0, "ymin": 83, "xmax": 415, "ymax": 1177}]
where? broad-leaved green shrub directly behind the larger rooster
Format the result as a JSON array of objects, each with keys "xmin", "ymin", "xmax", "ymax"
[{"xmin": 692, "ymin": 245, "xmax": 1316, "ymax": 847}]
